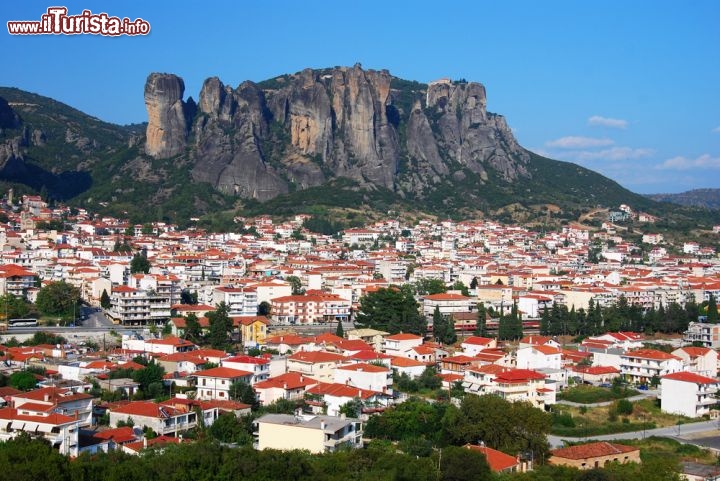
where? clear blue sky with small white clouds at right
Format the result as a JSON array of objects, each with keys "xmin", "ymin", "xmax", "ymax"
[{"xmin": 0, "ymin": 0, "xmax": 720, "ymax": 193}]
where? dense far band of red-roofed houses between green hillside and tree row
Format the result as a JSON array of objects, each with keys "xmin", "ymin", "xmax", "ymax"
[{"xmin": 0, "ymin": 196, "xmax": 720, "ymax": 332}]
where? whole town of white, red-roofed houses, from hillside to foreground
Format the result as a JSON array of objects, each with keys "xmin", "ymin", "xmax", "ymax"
[{"xmin": 0, "ymin": 192, "xmax": 720, "ymax": 462}]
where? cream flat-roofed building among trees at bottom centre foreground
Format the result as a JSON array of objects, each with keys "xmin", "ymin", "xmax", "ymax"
[{"xmin": 255, "ymin": 414, "xmax": 363, "ymax": 454}]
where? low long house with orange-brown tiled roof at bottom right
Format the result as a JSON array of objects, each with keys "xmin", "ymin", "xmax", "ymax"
[{"xmin": 548, "ymin": 441, "xmax": 641, "ymax": 469}]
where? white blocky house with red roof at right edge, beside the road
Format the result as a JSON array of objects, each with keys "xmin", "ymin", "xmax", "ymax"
[{"xmin": 658, "ymin": 372, "xmax": 720, "ymax": 418}]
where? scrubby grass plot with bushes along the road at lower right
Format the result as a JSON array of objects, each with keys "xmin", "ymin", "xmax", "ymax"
[{"xmin": 550, "ymin": 399, "xmax": 697, "ymax": 437}]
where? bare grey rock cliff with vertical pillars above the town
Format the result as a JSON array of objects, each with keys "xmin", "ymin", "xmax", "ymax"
[{"xmin": 145, "ymin": 65, "xmax": 530, "ymax": 200}]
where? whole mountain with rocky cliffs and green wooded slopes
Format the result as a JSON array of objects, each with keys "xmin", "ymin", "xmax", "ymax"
[{"xmin": 0, "ymin": 65, "xmax": 716, "ymax": 232}]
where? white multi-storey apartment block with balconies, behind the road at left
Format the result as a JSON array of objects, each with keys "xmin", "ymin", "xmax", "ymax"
[{"xmin": 105, "ymin": 286, "xmax": 171, "ymax": 326}]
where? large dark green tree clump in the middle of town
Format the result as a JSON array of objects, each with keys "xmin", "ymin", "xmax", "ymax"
[{"xmin": 355, "ymin": 286, "xmax": 427, "ymax": 334}]
